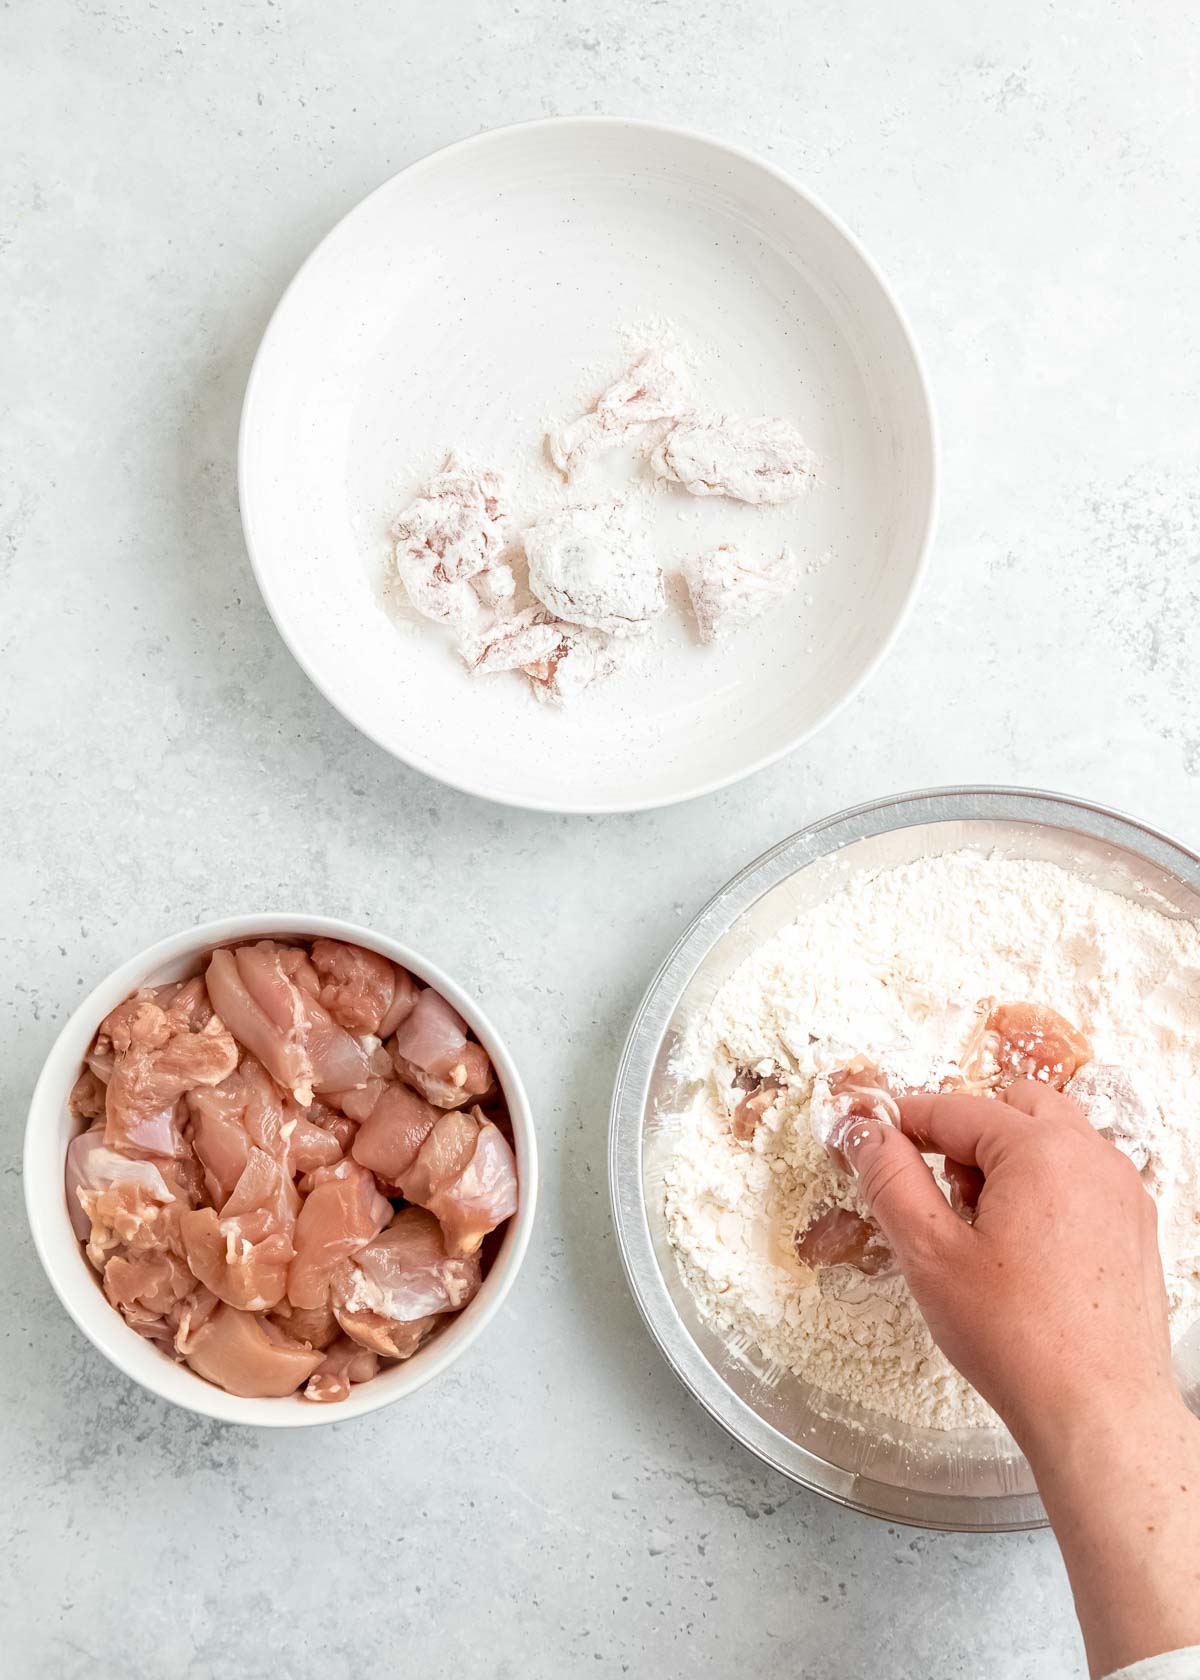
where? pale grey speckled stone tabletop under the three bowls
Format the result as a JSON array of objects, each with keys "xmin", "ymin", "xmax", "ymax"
[{"xmin": 0, "ymin": 0, "xmax": 1200, "ymax": 1680}]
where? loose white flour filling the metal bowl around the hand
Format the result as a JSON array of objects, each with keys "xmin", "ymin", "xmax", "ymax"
[{"xmin": 666, "ymin": 852, "xmax": 1200, "ymax": 1428}]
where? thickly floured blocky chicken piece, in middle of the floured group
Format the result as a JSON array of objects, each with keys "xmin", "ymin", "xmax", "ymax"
[{"xmin": 524, "ymin": 497, "xmax": 666, "ymax": 635}]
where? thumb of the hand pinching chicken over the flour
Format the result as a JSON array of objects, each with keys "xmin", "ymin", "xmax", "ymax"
[{"xmin": 842, "ymin": 1121, "xmax": 968, "ymax": 1272}]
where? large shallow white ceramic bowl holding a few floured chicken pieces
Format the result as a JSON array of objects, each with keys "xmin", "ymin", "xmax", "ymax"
[{"xmin": 239, "ymin": 118, "xmax": 938, "ymax": 811}]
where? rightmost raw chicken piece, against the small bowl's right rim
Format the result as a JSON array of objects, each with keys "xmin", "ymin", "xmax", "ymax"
[{"xmin": 400, "ymin": 1109, "xmax": 518, "ymax": 1255}]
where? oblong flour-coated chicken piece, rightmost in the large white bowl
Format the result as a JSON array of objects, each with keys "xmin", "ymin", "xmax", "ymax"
[{"xmin": 650, "ymin": 415, "xmax": 817, "ymax": 504}]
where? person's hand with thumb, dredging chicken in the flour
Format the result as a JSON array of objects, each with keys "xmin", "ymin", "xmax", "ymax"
[{"xmin": 842, "ymin": 1080, "xmax": 1176, "ymax": 1450}]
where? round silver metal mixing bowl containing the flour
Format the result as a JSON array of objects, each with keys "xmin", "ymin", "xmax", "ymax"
[{"xmin": 608, "ymin": 788, "xmax": 1200, "ymax": 1532}]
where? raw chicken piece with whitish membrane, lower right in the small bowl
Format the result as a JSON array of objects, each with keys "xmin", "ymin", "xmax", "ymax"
[{"xmin": 333, "ymin": 1208, "xmax": 481, "ymax": 1359}]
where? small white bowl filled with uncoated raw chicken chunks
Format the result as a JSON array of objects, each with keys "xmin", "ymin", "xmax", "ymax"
[{"xmin": 25, "ymin": 916, "xmax": 538, "ymax": 1428}]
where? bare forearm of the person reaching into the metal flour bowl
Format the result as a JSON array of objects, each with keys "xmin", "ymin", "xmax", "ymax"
[{"xmin": 1018, "ymin": 1393, "xmax": 1200, "ymax": 1675}]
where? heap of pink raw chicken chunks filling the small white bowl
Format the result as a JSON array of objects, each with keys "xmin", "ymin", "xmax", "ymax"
[{"xmin": 64, "ymin": 941, "xmax": 516, "ymax": 1403}]
